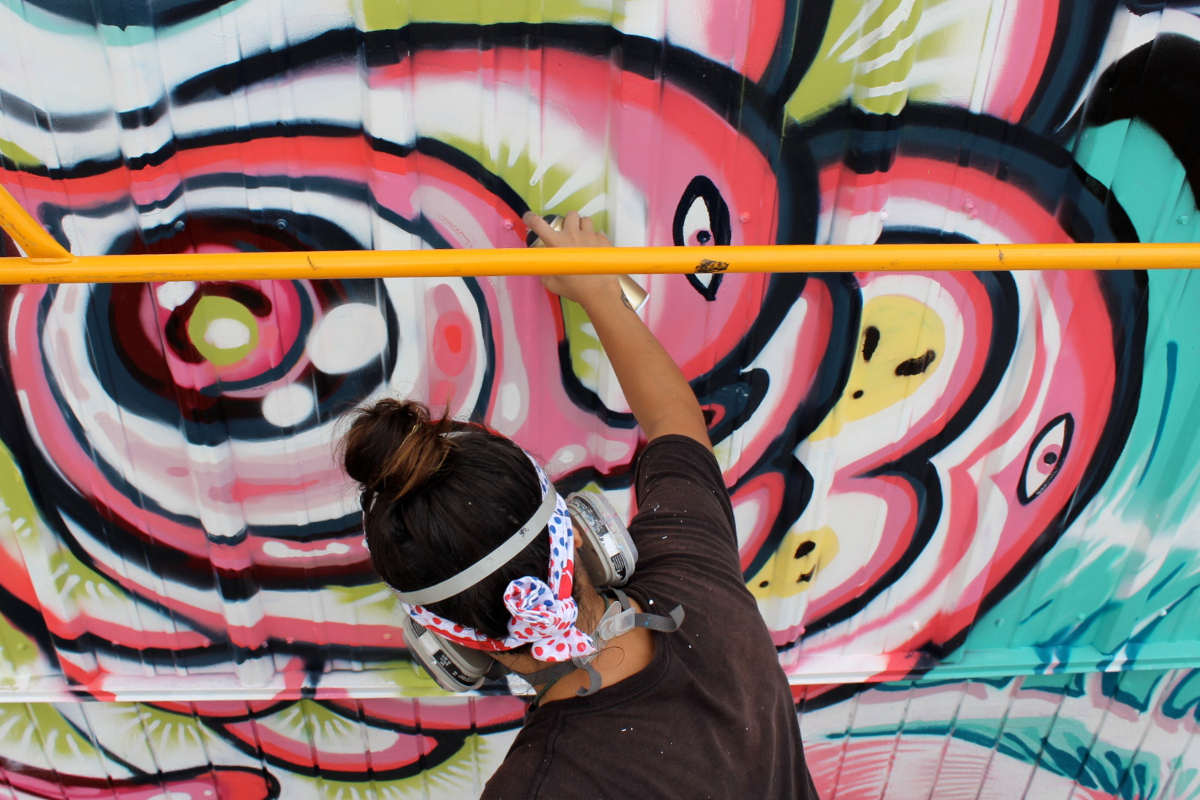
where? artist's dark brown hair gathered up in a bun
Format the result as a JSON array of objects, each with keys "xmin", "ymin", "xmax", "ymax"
[{"xmin": 341, "ymin": 398, "xmax": 550, "ymax": 638}]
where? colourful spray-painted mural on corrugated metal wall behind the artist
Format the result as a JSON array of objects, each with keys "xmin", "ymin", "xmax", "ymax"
[{"xmin": 0, "ymin": 0, "xmax": 1200, "ymax": 800}]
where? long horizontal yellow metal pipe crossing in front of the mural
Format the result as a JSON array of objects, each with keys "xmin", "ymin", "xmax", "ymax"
[{"xmin": 0, "ymin": 243, "xmax": 1200, "ymax": 283}]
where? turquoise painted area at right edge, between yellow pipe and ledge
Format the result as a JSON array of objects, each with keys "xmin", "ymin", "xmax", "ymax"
[{"xmin": 950, "ymin": 270, "xmax": 1200, "ymax": 672}]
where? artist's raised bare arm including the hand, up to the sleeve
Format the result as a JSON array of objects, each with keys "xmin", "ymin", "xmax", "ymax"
[{"xmin": 524, "ymin": 211, "xmax": 712, "ymax": 447}]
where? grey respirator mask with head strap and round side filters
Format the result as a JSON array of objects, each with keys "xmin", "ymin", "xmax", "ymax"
[{"xmin": 398, "ymin": 486, "xmax": 683, "ymax": 694}]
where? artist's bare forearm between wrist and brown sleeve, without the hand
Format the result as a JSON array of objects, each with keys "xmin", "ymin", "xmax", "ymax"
[{"xmin": 584, "ymin": 296, "xmax": 709, "ymax": 446}]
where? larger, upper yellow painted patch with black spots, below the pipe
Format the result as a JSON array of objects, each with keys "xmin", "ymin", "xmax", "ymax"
[{"xmin": 809, "ymin": 295, "xmax": 946, "ymax": 441}]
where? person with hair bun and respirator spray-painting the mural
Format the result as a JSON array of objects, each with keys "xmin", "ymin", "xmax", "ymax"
[{"xmin": 343, "ymin": 212, "xmax": 816, "ymax": 800}]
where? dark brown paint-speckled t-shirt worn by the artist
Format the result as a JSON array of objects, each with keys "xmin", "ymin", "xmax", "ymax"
[{"xmin": 482, "ymin": 435, "xmax": 817, "ymax": 800}]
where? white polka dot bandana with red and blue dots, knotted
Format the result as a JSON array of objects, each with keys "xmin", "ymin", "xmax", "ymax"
[{"xmin": 401, "ymin": 458, "xmax": 596, "ymax": 663}]
